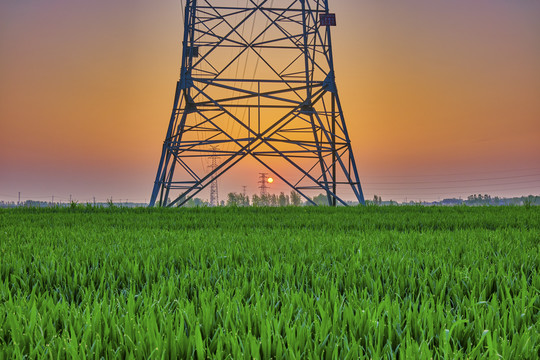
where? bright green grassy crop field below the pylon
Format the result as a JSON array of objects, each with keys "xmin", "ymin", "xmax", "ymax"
[{"xmin": 0, "ymin": 206, "xmax": 540, "ymax": 359}]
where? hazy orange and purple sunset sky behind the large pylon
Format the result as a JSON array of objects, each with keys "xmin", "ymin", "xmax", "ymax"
[{"xmin": 0, "ymin": 0, "xmax": 540, "ymax": 202}]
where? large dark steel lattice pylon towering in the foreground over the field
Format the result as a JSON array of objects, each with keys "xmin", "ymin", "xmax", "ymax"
[{"xmin": 150, "ymin": 0, "xmax": 364, "ymax": 206}]
